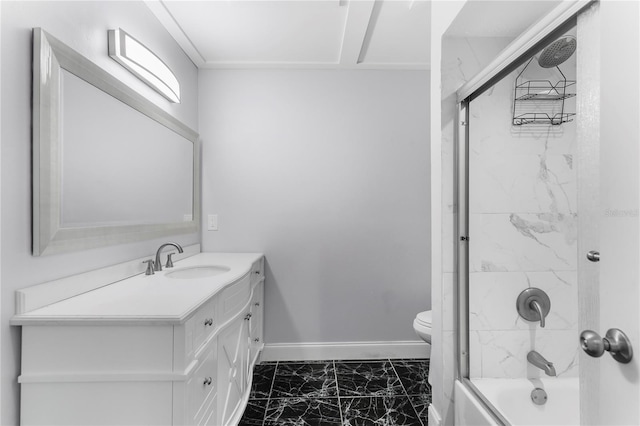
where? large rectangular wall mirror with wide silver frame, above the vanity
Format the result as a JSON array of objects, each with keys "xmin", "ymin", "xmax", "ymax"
[{"xmin": 33, "ymin": 28, "xmax": 200, "ymax": 256}]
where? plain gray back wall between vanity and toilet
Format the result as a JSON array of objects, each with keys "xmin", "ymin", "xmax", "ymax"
[{"xmin": 199, "ymin": 70, "xmax": 431, "ymax": 343}]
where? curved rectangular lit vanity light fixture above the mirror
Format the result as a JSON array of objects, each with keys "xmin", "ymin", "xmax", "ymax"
[{"xmin": 108, "ymin": 28, "xmax": 180, "ymax": 103}]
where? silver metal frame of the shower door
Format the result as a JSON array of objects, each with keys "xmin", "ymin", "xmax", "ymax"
[{"xmin": 454, "ymin": 0, "xmax": 597, "ymax": 425}]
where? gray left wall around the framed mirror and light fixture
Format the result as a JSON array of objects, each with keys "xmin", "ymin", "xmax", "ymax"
[{"xmin": 0, "ymin": 1, "xmax": 200, "ymax": 425}]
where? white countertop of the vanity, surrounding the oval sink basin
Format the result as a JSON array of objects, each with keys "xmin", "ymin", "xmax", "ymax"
[{"xmin": 11, "ymin": 253, "xmax": 262, "ymax": 325}]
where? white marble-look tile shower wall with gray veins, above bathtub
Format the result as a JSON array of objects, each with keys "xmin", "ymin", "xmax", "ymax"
[{"xmin": 469, "ymin": 59, "xmax": 579, "ymax": 378}]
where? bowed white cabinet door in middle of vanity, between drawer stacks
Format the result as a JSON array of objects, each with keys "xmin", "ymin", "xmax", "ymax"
[{"xmin": 218, "ymin": 310, "xmax": 249, "ymax": 425}]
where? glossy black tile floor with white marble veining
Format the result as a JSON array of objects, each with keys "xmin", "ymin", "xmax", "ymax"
[{"xmin": 240, "ymin": 359, "xmax": 431, "ymax": 426}]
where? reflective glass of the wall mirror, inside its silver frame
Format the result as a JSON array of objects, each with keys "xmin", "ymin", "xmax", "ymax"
[{"xmin": 61, "ymin": 70, "xmax": 193, "ymax": 228}]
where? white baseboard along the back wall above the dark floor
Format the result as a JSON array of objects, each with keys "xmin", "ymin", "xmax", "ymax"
[{"xmin": 260, "ymin": 341, "xmax": 431, "ymax": 361}]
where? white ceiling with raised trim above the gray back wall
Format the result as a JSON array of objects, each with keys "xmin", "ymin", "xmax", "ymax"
[{"xmin": 146, "ymin": 0, "xmax": 431, "ymax": 69}]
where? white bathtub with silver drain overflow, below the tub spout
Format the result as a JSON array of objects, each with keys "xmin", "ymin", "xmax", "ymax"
[{"xmin": 455, "ymin": 378, "xmax": 580, "ymax": 425}]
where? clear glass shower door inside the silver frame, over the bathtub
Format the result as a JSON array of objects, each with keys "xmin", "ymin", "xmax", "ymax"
[{"xmin": 459, "ymin": 15, "xmax": 581, "ymax": 424}]
